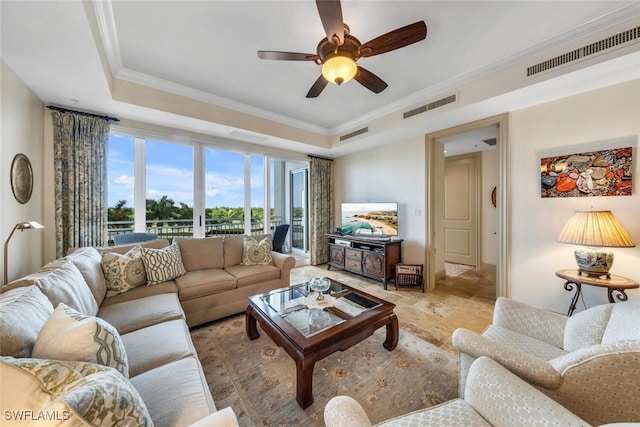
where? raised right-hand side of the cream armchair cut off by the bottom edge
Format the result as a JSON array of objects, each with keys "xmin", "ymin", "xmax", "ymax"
[{"xmin": 464, "ymin": 357, "xmax": 589, "ymax": 426}]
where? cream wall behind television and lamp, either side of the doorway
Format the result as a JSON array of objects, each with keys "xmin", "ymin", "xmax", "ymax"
[{"xmin": 334, "ymin": 80, "xmax": 640, "ymax": 313}]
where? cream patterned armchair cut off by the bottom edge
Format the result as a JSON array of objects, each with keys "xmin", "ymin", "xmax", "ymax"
[{"xmin": 324, "ymin": 357, "xmax": 589, "ymax": 427}]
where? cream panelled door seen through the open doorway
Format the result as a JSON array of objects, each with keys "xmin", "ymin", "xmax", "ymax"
[{"xmin": 444, "ymin": 154, "xmax": 478, "ymax": 267}]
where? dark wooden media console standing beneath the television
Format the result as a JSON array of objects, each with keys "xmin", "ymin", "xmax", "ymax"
[{"xmin": 327, "ymin": 234, "xmax": 402, "ymax": 289}]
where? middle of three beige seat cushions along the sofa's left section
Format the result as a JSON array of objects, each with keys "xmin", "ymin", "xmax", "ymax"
[{"xmin": 122, "ymin": 319, "xmax": 196, "ymax": 377}]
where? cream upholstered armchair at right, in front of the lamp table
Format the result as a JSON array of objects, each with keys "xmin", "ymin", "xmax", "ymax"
[{"xmin": 452, "ymin": 298, "xmax": 640, "ymax": 424}]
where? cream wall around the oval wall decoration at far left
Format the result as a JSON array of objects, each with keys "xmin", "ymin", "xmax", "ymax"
[{"xmin": 0, "ymin": 61, "xmax": 44, "ymax": 286}]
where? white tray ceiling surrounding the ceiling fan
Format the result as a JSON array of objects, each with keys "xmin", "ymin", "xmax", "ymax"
[{"xmin": 0, "ymin": 0, "xmax": 640, "ymax": 154}]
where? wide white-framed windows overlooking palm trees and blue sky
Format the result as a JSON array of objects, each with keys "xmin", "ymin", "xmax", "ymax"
[{"xmin": 107, "ymin": 129, "xmax": 302, "ymax": 249}]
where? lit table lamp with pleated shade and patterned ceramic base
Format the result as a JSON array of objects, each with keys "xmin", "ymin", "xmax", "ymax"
[{"xmin": 558, "ymin": 211, "xmax": 635, "ymax": 278}]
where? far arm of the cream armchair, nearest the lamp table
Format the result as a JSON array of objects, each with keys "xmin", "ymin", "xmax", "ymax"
[{"xmin": 493, "ymin": 297, "xmax": 567, "ymax": 348}]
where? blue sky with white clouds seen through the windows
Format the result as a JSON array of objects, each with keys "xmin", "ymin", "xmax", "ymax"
[{"xmin": 107, "ymin": 135, "xmax": 264, "ymax": 207}]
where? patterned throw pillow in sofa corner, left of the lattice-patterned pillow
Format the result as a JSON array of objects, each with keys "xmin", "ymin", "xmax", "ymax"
[{"xmin": 102, "ymin": 245, "xmax": 147, "ymax": 298}]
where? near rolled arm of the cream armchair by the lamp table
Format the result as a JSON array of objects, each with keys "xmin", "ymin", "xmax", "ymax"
[{"xmin": 451, "ymin": 328, "xmax": 562, "ymax": 389}]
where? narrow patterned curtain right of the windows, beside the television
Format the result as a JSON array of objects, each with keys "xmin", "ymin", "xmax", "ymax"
[{"xmin": 309, "ymin": 157, "xmax": 333, "ymax": 265}]
